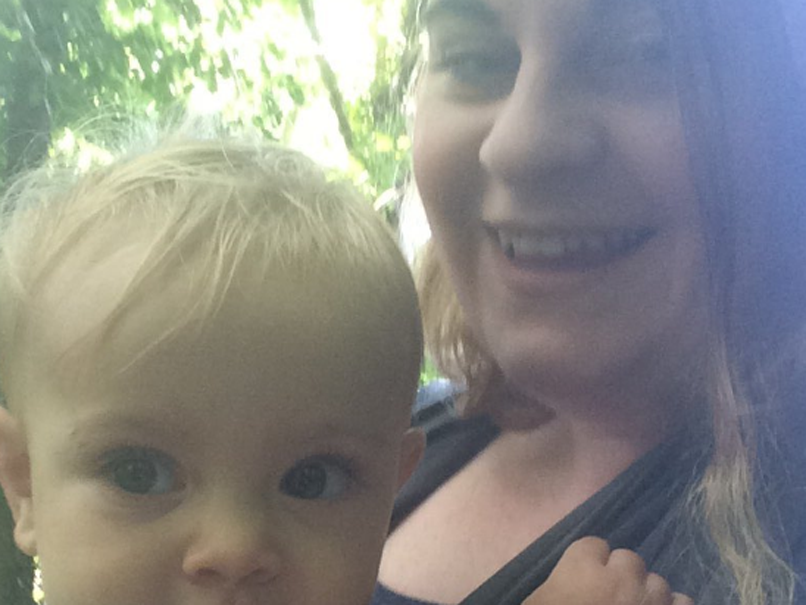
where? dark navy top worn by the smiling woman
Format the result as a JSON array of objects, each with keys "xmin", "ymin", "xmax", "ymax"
[{"xmin": 371, "ymin": 400, "xmax": 806, "ymax": 605}]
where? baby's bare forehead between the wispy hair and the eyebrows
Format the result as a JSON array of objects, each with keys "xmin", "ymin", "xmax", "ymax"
[{"xmin": 19, "ymin": 238, "xmax": 419, "ymax": 417}]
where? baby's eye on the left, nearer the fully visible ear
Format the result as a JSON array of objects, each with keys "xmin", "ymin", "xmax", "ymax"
[{"xmin": 103, "ymin": 448, "xmax": 181, "ymax": 496}]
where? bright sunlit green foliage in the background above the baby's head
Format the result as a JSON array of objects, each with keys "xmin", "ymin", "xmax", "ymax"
[{"xmin": 0, "ymin": 0, "xmax": 416, "ymax": 197}]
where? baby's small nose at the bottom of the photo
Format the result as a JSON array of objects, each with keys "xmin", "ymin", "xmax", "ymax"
[{"xmin": 182, "ymin": 507, "xmax": 282, "ymax": 586}]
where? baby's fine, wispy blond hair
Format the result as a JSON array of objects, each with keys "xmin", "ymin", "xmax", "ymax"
[{"xmin": 0, "ymin": 135, "xmax": 422, "ymax": 408}]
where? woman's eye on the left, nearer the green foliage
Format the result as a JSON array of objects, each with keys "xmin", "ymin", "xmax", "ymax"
[{"xmin": 430, "ymin": 49, "xmax": 520, "ymax": 96}]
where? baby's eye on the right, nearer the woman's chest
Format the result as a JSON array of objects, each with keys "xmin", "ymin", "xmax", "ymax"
[{"xmin": 280, "ymin": 457, "xmax": 353, "ymax": 500}]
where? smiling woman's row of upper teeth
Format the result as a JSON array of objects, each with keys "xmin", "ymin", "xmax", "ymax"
[{"xmin": 497, "ymin": 229, "xmax": 652, "ymax": 261}]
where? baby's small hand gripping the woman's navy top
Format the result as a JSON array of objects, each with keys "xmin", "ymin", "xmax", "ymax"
[{"xmin": 523, "ymin": 537, "xmax": 694, "ymax": 605}]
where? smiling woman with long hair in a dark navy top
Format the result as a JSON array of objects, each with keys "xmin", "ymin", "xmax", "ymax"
[{"xmin": 375, "ymin": 0, "xmax": 806, "ymax": 605}]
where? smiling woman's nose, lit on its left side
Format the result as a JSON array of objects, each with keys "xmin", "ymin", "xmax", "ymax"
[{"xmin": 479, "ymin": 63, "xmax": 606, "ymax": 180}]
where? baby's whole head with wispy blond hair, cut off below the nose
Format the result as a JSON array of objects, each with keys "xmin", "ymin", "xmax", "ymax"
[{"xmin": 0, "ymin": 139, "xmax": 430, "ymax": 605}]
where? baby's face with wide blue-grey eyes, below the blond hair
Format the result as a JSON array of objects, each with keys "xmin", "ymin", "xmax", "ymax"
[{"xmin": 7, "ymin": 245, "xmax": 419, "ymax": 605}]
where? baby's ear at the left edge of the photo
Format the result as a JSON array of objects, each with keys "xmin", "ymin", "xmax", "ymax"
[{"xmin": 0, "ymin": 406, "xmax": 36, "ymax": 556}]
